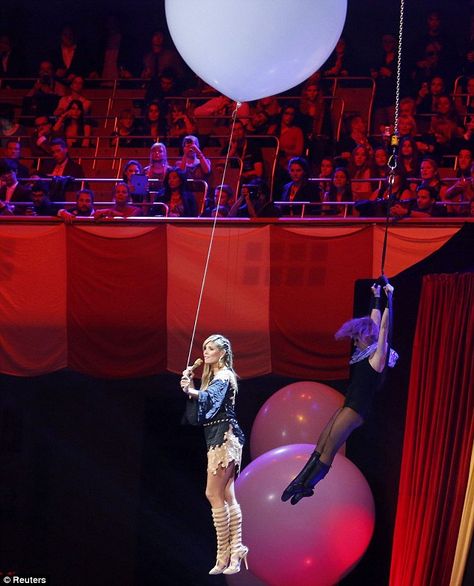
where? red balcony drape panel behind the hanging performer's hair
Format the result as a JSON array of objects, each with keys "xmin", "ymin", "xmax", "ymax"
[{"xmin": 270, "ymin": 227, "xmax": 372, "ymax": 380}]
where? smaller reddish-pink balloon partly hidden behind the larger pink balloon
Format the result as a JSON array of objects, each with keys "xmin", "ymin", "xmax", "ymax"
[{"xmin": 250, "ymin": 381, "xmax": 345, "ymax": 458}]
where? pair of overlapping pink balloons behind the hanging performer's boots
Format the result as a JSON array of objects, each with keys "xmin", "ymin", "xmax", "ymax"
[{"xmin": 227, "ymin": 382, "xmax": 374, "ymax": 586}]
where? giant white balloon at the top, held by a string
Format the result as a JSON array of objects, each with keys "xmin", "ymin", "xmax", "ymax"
[{"xmin": 165, "ymin": 0, "xmax": 347, "ymax": 102}]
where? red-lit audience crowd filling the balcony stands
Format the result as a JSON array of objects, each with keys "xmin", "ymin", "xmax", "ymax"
[{"xmin": 0, "ymin": 11, "xmax": 474, "ymax": 217}]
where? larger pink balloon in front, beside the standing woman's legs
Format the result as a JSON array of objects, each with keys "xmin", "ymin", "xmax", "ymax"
[{"xmin": 236, "ymin": 444, "xmax": 375, "ymax": 586}]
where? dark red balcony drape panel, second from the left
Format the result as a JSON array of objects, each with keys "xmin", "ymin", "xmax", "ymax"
[{"xmin": 67, "ymin": 226, "xmax": 167, "ymax": 377}]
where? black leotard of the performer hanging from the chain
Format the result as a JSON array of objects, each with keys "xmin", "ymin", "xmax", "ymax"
[{"xmin": 344, "ymin": 356, "xmax": 383, "ymax": 419}]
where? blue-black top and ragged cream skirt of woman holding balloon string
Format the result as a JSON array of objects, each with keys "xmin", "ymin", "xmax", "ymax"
[{"xmin": 198, "ymin": 373, "xmax": 245, "ymax": 474}]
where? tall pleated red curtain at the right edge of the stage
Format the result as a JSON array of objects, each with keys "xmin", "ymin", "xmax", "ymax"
[{"xmin": 390, "ymin": 273, "xmax": 474, "ymax": 586}]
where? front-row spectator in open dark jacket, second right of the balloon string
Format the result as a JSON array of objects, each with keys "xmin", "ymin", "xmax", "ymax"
[{"xmin": 277, "ymin": 157, "xmax": 321, "ymax": 216}]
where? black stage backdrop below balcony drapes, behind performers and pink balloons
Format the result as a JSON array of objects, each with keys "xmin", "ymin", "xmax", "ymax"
[{"xmin": 0, "ymin": 224, "xmax": 474, "ymax": 586}]
